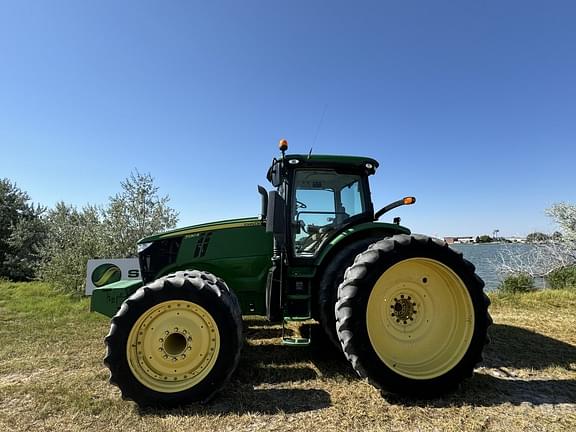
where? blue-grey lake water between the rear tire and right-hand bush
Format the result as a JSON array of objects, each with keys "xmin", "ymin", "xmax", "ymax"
[{"xmin": 450, "ymin": 243, "xmax": 533, "ymax": 291}]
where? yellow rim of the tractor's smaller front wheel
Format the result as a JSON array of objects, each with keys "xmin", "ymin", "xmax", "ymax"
[{"xmin": 126, "ymin": 300, "xmax": 220, "ymax": 393}]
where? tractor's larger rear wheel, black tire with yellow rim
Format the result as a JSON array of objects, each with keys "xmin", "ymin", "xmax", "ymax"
[{"xmin": 336, "ymin": 234, "xmax": 492, "ymax": 397}]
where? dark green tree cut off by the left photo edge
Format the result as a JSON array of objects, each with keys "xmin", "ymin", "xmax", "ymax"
[{"xmin": 0, "ymin": 178, "xmax": 46, "ymax": 280}]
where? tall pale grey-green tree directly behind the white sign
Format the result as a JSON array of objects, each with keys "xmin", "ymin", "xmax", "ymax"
[{"xmin": 103, "ymin": 171, "xmax": 178, "ymax": 258}]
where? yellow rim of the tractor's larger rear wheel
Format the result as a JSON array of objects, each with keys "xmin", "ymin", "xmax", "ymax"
[{"xmin": 366, "ymin": 258, "xmax": 474, "ymax": 379}]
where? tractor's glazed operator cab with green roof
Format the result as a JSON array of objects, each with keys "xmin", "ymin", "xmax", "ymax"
[{"xmin": 267, "ymin": 148, "xmax": 378, "ymax": 259}]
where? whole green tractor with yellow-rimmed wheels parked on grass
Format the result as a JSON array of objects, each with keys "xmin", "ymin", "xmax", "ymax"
[{"xmin": 91, "ymin": 140, "xmax": 491, "ymax": 406}]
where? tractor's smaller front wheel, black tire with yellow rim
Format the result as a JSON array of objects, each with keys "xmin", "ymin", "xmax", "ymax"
[{"xmin": 104, "ymin": 270, "xmax": 242, "ymax": 407}]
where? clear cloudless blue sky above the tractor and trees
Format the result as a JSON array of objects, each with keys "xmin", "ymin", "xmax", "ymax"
[{"xmin": 0, "ymin": 0, "xmax": 576, "ymax": 235}]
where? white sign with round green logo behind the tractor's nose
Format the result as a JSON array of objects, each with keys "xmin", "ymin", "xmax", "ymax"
[{"xmin": 86, "ymin": 258, "xmax": 140, "ymax": 295}]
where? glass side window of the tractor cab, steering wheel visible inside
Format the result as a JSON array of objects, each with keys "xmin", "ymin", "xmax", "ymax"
[{"xmin": 292, "ymin": 170, "xmax": 365, "ymax": 256}]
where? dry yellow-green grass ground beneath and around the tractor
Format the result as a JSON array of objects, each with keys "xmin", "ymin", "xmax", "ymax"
[{"xmin": 0, "ymin": 283, "xmax": 576, "ymax": 431}]
